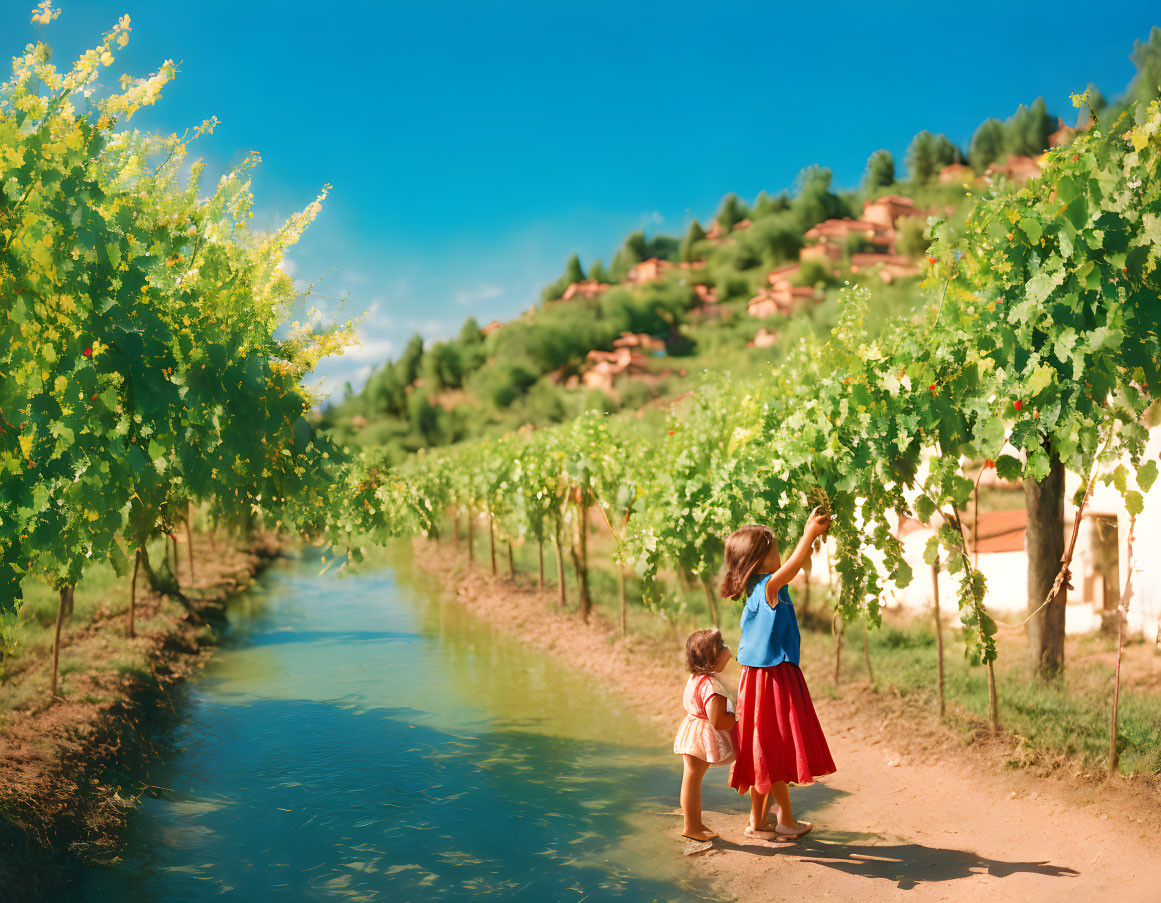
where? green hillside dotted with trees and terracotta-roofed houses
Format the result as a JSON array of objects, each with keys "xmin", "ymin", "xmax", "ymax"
[{"xmin": 319, "ymin": 87, "xmax": 1123, "ymax": 460}]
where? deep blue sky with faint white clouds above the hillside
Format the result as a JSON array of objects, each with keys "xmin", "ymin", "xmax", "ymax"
[{"xmin": 9, "ymin": 0, "xmax": 1161, "ymax": 389}]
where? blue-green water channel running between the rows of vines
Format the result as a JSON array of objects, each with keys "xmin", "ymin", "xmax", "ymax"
[{"xmin": 58, "ymin": 540, "xmax": 713, "ymax": 903}]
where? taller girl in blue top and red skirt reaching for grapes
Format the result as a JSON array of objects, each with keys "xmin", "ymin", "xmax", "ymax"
[{"xmin": 722, "ymin": 508, "xmax": 835, "ymax": 843}]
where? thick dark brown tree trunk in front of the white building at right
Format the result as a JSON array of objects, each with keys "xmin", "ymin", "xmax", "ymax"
[{"xmin": 1024, "ymin": 455, "xmax": 1068, "ymax": 678}]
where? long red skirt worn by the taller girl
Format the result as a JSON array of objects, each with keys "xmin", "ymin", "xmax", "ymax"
[{"xmin": 729, "ymin": 662, "xmax": 835, "ymax": 794}]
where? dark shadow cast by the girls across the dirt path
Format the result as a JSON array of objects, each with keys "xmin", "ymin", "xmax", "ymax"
[{"xmin": 715, "ymin": 831, "xmax": 1080, "ymax": 890}]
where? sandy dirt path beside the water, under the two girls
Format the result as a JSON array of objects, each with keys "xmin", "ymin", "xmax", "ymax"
[{"xmin": 418, "ymin": 546, "xmax": 1161, "ymax": 903}]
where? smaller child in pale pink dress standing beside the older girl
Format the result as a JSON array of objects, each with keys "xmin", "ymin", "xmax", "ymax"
[{"xmin": 673, "ymin": 627, "xmax": 736, "ymax": 841}]
